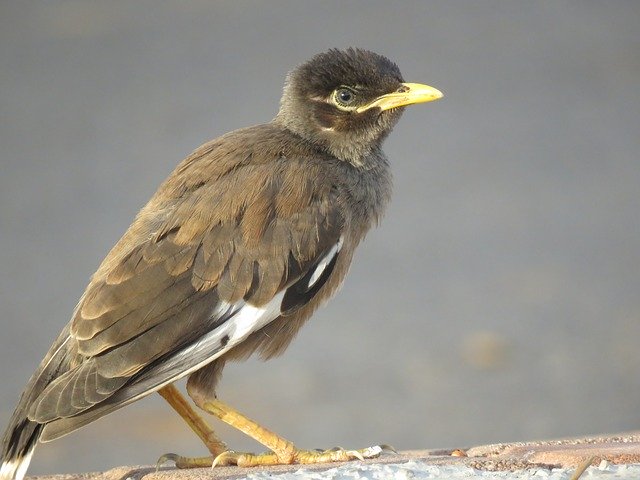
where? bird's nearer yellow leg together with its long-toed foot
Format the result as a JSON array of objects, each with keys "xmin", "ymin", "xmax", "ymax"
[{"xmin": 199, "ymin": 399, "xmax": 388, "ymax": 467}]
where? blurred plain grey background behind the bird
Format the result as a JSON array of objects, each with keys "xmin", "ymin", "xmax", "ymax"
[{"xmin": 0, "ymin": 0, "xmax": 640, "ymax": 473}]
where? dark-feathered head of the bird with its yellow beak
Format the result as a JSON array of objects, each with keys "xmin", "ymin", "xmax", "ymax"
[{"xmin": 276, "ymin": 48, "xmax": 442, "ymax": 165}]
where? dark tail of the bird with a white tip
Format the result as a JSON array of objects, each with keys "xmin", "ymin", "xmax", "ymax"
[{"xmin": 0, "ymin": 329, "xmax": 69, "ymax": 480}]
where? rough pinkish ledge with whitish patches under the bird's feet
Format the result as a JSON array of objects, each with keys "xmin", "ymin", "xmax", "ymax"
[{"xmin": 32, "ymin": 432, "xmax": 640, "ymax": 480}]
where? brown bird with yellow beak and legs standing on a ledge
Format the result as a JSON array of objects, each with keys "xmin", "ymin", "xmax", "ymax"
[{"xmin": 0, "ymin": 47, "xmax": 443, "ymax": 480}]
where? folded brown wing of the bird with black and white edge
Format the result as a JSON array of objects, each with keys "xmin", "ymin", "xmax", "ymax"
[{"xmin": 29, "ymin": 134, "xmax": 343, "ymax": 433}]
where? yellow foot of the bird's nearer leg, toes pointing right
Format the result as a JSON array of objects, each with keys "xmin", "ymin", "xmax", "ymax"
[{"xmin": 212, "ymin": 445, "xmax": 395, "ymax": 467}]
